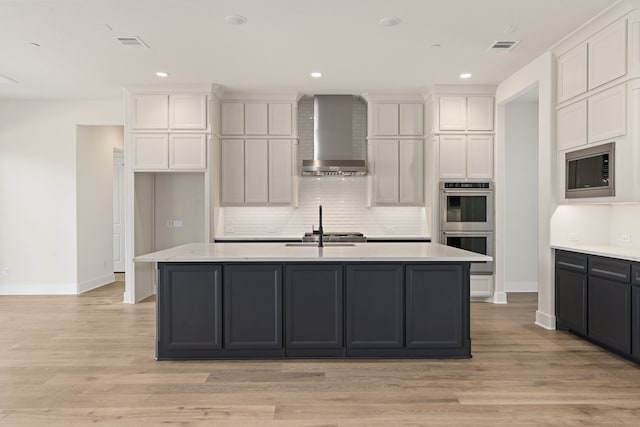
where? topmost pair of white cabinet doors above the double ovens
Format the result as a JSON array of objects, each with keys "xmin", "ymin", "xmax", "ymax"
[{"xmin": 438, "ymin": 95, "xmax": 494, "ymax": 131}]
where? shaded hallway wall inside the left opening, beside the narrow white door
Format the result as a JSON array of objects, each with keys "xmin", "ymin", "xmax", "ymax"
[{"xmin": 76, "ymin": 125, "xmax": 124, "ymax": 293}]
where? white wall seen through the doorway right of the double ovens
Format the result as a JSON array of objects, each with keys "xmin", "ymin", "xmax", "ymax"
[{"xmin": 502, "ymin": 97, "xmax": 538, "ymax": 292}]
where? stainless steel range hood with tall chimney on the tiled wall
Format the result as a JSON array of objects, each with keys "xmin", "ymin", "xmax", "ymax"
[{"xmin": 302, "ymin": 95, "xmax": 367, "ymax": 176}]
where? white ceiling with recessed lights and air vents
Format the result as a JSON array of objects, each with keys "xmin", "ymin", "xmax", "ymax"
[{"xmin": 0, "ymin": 0, "xmax": 616, "ymax": 98}]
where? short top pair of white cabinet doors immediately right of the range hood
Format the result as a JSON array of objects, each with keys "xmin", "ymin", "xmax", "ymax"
[{"xmin": 369, "ymin": 102, "xmax": 424, "ymax": 136}]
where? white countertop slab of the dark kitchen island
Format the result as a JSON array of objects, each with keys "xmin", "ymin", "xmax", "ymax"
[{"xmin": 134, "ymin": 242, "xmax": 492, "ymax": 262}]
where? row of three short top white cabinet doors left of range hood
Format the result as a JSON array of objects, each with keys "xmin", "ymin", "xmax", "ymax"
[{"xmin": 221, "ymin": 101, "xmax": 294, "ymax": 136}]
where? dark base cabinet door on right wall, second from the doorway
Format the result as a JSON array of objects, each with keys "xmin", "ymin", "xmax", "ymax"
[{"xmin": 588, "ymin": 276, "xmax": 631, "ymax": 354}]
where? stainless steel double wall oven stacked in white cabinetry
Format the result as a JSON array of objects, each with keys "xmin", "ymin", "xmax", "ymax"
[{"xmin": 440, "ymin": 181, "xmax": 495, "ymax": 274}]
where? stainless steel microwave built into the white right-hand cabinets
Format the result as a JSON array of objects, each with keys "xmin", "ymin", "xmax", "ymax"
[{"xmin": 565, "ymin": 142, "xmax": 616, "ymax": 199}]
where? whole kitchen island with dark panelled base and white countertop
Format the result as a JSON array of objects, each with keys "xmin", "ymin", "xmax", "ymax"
[{"xmin": 135, "ymin": 243, "xmax": 491, "ymax": 360}]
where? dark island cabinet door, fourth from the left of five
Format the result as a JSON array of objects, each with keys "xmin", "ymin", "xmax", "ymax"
[{"xmin": 345, "ymin": 264, "xmax": 404, "ymax": 356}]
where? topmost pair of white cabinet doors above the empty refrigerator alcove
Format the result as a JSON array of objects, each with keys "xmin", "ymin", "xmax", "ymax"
[{"xmin": 131, "ymin": 94, "xmax": 207, "ymax": 130}]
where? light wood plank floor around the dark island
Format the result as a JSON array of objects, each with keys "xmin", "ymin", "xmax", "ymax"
[{"xmin": 0, "ymin": 282, "xmax": 640, "ymax": 426}]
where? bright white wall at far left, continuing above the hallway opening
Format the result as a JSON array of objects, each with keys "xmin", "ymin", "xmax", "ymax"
[{"xmin": 0, "ymin": 99, "xmax": 124, "ymax": 294}]
